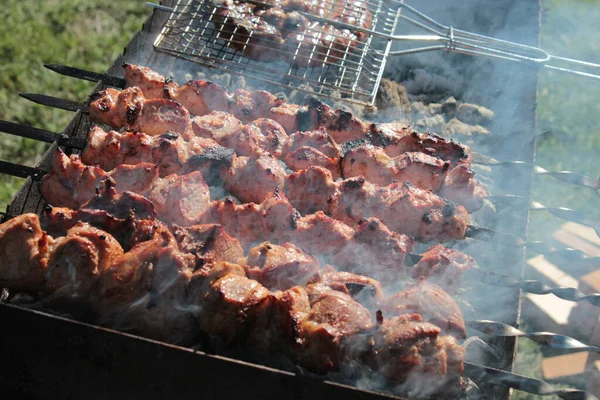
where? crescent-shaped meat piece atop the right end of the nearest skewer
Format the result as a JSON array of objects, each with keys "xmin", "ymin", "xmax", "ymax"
[{"xmin": 382, "ymin": 279, "xmax": 467, "ymax": 339}]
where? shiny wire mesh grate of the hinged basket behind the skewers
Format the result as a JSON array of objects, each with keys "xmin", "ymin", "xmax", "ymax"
[{"xmin": 154, "ymin": 0, "xmax": 400, "ymax": 105}]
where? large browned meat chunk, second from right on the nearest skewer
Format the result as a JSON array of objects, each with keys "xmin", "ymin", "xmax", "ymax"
[{"xmin": 298, "ymin": 283, "xmax": 375, "ymax": 373}]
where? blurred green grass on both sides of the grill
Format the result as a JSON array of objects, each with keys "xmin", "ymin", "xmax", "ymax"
[{"xmin": 0, "ymin": 0, "xmax": 600, "ymax": 399}]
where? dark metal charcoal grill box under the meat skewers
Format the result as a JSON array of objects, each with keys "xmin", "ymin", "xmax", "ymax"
[{"xmin": 0, "ymin": 0, "xmax": 596, "ymax": 399}]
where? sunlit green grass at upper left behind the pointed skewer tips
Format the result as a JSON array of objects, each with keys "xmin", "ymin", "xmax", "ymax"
[{"xmin": 0, "ymin": 0, "xmax": 151, "ymax": 206}]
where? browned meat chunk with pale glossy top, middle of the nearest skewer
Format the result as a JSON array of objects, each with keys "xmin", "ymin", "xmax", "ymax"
[{"xmin": 188, "ymin": 262, "xmax": 273, "ymax": 345}]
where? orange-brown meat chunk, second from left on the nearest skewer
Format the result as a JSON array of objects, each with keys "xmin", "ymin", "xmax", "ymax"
[{"xmin": 45, "ymin": 222, "xmax": 123, "ymax": 302}]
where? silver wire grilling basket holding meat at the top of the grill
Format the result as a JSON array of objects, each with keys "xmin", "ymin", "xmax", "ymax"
[{"xmin": 154, "ymin": 0, "xmax": 402, "ymax": 106}]
